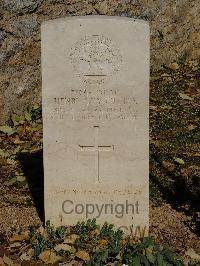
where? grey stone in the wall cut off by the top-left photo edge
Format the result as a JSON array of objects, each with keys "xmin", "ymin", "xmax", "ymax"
[{"xmin": 3, "ymin": 0, "xmax": 43, "ymax": 14}]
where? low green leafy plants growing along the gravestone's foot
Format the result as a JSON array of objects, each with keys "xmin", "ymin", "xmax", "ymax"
[{"xmin": 26, "ymin": 219, "xmax": 184, "ymax": 266}]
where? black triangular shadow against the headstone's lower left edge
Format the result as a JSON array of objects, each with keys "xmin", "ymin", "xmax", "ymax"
[{"xmin": 18, "ymin": 150, "xmax": 45, "ymax": 224}]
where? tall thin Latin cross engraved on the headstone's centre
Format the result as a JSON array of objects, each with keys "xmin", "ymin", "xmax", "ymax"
[{"xmin": 79, "ymin": 126, "xmax": 114, "ymax": 183}]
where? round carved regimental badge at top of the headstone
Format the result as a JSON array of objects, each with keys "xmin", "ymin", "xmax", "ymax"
[{"xmin": 70, "ymin": 35, "xmax": 122, "ymax": 84}]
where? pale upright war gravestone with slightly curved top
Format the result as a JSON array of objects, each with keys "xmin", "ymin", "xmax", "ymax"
[{"xmin": 42, "ymin": 16, "xmax": 149, "ymax": 234}]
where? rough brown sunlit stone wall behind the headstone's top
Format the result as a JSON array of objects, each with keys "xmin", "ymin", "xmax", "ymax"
[{"xmin": 0, "ymin": 0, "xmax": 200, "ymax": 124}]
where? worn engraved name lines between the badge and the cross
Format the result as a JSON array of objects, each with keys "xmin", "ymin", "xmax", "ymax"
[{"xmin": 53, "ymin": 89, "xmax": 137, "ymax": 120}]
